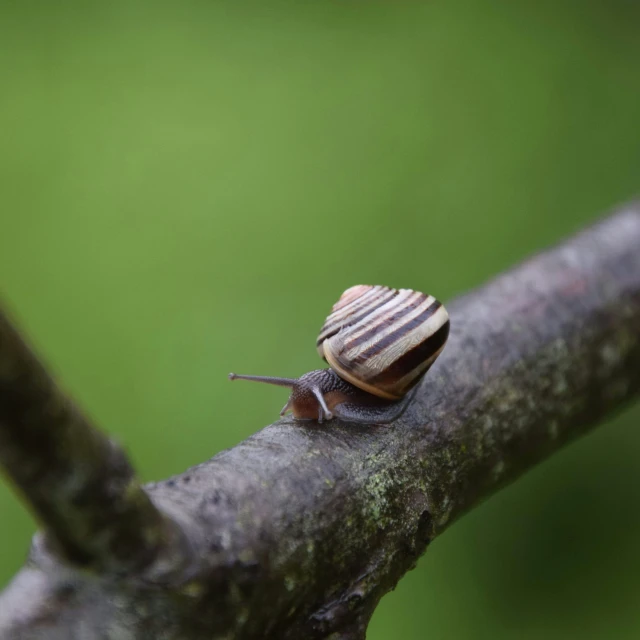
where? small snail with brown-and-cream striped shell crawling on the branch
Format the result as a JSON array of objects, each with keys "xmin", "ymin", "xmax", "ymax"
[{"xmin": 229, "ymin": 285, "xmax": 449, "ymax": 424}]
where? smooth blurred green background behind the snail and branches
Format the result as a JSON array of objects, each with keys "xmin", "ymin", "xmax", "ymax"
[{"xmin": 0, "ymin": 0, "xmax": 640, "ymax": 640}]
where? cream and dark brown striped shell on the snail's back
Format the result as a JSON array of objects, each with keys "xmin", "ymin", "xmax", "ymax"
[{"xmin": 316, "ymin": 284, "xmax": 449, "ymax": 400}]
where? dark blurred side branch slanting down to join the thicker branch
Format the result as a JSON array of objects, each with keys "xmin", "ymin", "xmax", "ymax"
[{"xmin": 0, "ymin": 310, "xmax": 191, "ymax": 575}]
